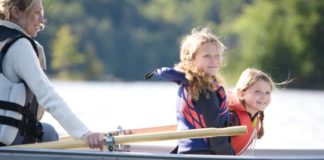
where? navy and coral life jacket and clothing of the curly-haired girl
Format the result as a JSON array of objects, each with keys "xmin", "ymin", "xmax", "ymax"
[{"xmin": 145, "ymin": 67, "xmax": 233, "ymax": 154}]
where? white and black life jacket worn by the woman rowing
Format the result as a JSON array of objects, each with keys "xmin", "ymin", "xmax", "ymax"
[{"xmin": 0, "ymin": 26, "xmax": 42, "ymax": 146}]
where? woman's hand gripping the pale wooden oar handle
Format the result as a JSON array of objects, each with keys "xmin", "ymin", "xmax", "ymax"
[{"xmin": 81, "ymin": 132, "xmax": 104, "ymax": 151}]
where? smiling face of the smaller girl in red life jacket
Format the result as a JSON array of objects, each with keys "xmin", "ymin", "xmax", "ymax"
[{"xmin": 240, "ymin": 80, "xmax": 272, "ymax": 114}]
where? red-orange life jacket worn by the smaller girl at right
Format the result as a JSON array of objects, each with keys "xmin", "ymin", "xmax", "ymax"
[{"xmin": 229, "ymin": 102, "xmax": 260, "ymax": 155}]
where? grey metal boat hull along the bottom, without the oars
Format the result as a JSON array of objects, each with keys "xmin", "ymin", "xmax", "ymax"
[{"xmin": 0, "ymin": 145, "xmax": 324, "ymax": 160}]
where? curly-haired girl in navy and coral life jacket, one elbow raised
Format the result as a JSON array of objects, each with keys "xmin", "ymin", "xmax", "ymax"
[{"xmin": 146, "ymin": 28, "xmax": 233, "ymax": 154}]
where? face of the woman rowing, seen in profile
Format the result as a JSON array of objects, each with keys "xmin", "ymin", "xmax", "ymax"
[{"xmin": 16, "ymin": 0, "xmax": 45, "ymax": 37}]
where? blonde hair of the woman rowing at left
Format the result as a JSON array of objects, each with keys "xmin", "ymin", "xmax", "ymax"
[{"xmin": 0, "ymin": 0, "xmax": 35, "ymax": 21}]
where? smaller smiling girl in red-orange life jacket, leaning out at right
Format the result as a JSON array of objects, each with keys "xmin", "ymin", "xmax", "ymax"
[{"xmin": 230, "ymin": 68, "xmax": 275, "ymax": 155}]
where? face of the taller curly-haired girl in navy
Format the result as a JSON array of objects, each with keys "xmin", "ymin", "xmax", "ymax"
[{"xmin": 193, "ymin": 42, "xmax": 221, "ymax": 75}]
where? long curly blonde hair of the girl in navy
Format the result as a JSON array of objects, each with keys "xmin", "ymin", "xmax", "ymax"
[{"xmin": 175, "ymin": 27, "xmax": 226, "ymax": 100}]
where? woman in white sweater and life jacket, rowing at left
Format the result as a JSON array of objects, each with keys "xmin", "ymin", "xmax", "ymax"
[{"xmin": 0, "ymin": 0, "xmax": 103, "ymax": 149}]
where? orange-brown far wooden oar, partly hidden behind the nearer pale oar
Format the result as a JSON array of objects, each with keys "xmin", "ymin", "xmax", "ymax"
[{"xmin": 60, "ymin": 124, "xmax": 177, "ymax": 140}]
